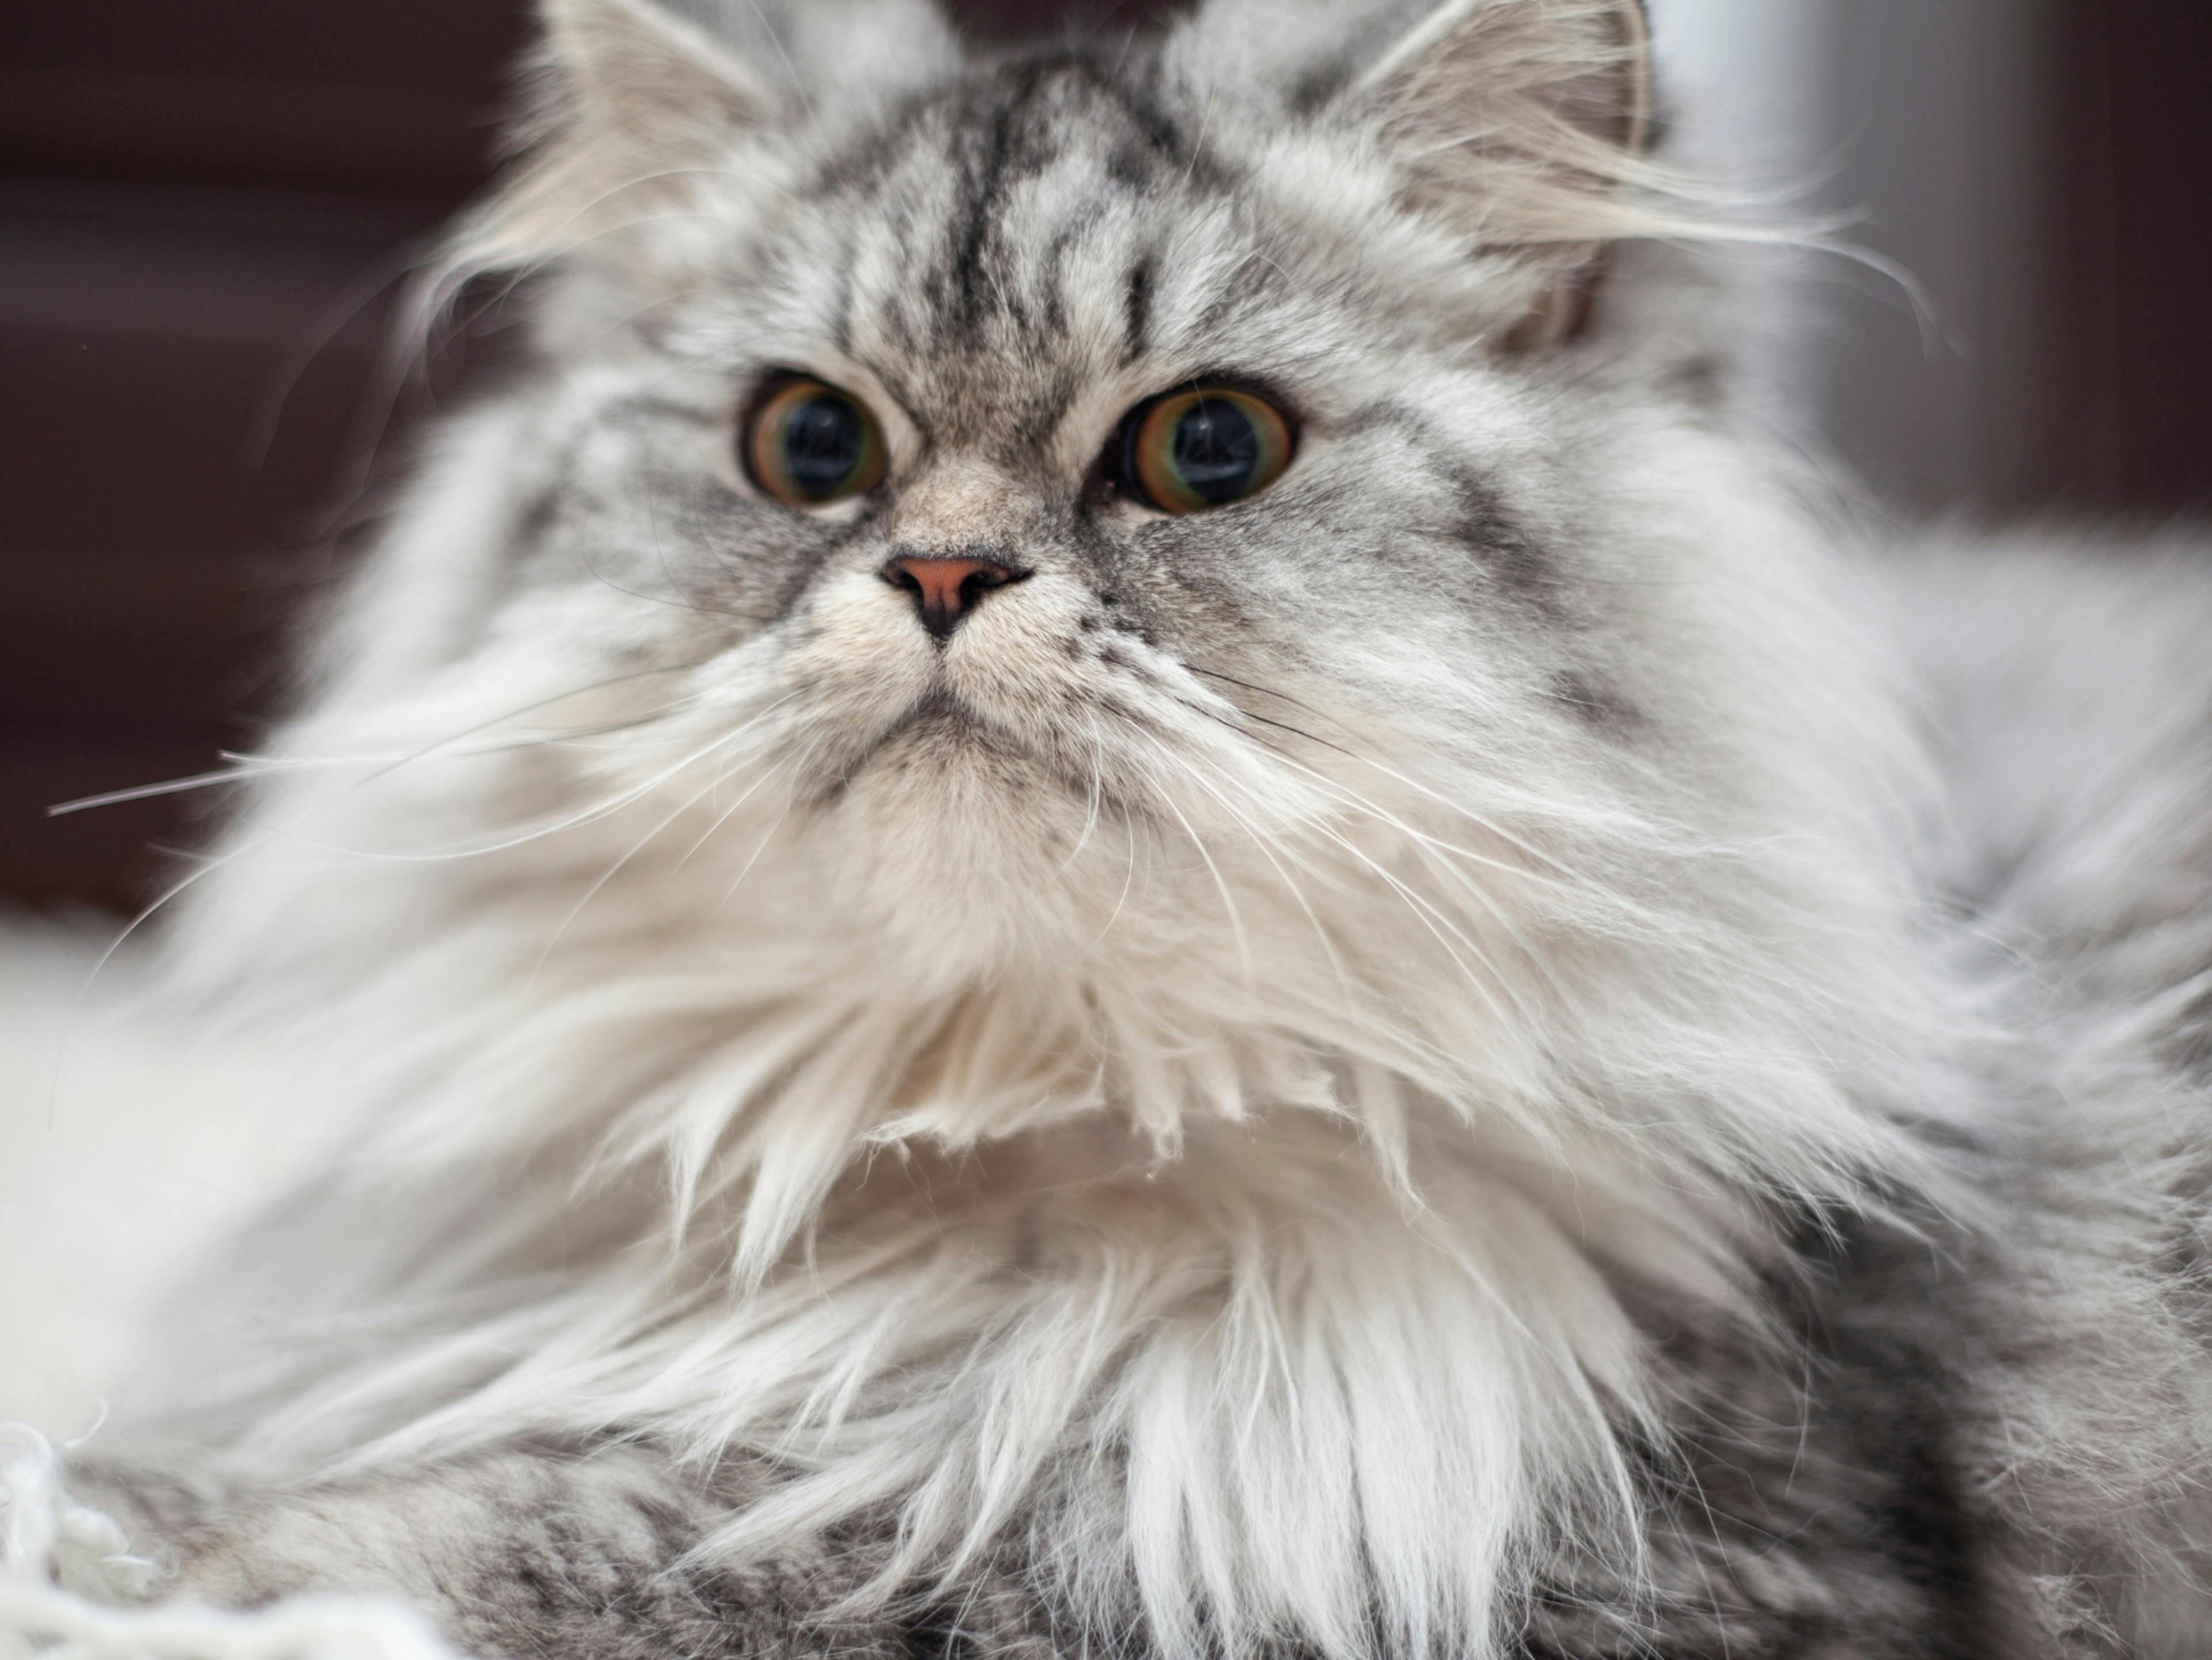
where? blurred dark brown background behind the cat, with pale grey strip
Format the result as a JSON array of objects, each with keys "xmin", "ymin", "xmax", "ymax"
[{"xmin": 0, "ymin": 0, "xmax": 2212, "ymax": 907}]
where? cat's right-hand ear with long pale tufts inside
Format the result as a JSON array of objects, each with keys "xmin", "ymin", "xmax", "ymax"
[{"xmin": 1170, "ymin": 0, "xmax": 1652, "ymax": 345}]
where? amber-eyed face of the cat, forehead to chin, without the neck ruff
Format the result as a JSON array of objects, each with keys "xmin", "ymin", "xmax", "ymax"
[{"xmin": 345, "ymin": 5, "xmax": 1752, "ymax": 974}]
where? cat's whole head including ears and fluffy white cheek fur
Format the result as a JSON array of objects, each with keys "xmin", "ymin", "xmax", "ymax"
[{"xmin": 207, "ymin": 0, "xmax": 1937, "ymax": 1195}]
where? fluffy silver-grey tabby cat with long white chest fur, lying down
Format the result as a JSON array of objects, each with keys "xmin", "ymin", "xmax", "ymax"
[{"xmin": 7, "ymin": 0, "xmax": 2212, "ymax": 1660}]
